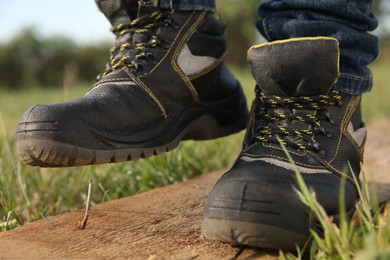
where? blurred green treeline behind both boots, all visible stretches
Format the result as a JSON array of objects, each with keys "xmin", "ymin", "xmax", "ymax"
[{"xmin": 0, "ymin": 0, "xmax": 390, "ymax": 89}]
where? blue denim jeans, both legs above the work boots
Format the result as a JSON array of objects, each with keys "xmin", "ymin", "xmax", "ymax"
[{"xmin": 160, "ymin": 0, "xmax": 379, "ymax": 94}]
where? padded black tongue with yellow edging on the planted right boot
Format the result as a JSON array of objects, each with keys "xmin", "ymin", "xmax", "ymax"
[{"xmin": 248, "ymin": 37, "xmax": 339, "ymax": 97}]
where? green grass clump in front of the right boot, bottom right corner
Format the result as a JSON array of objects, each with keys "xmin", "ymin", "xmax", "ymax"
[{"xmin": 280, "ymin": 141, "xmax": 390, "ymax": 260}]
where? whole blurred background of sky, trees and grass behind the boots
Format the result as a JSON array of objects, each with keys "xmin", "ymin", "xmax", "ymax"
[{"xmin": 0, "ymin": 0, "xmax": 390, "ymax": 232}]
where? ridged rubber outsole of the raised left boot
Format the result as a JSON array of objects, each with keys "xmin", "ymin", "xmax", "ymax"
[{"xmin": 16, "ymin": 115, "xmax": 246, "ymax": 167}]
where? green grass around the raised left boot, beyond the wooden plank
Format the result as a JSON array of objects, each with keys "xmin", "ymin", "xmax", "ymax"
[{"xmin": 0, "ymin": 78, "xmax": 253, "ymax": 230}]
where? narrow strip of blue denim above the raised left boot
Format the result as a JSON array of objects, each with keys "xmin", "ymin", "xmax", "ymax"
[{"xmin": 160, "ymin": 0, "xmax": 215, "ymax": 12}]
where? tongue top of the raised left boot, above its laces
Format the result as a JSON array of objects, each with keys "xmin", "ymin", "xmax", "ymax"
[{"xmin": 95, "ymin": 0, "xmax": 131, "ymax": 26}]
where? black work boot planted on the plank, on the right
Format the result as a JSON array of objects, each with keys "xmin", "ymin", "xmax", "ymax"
[{"xmin": 202, "ymin": 37, "xmax": 366, "ymax": 250}]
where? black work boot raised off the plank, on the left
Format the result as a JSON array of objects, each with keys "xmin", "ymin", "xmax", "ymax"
[{"xmin": 16, "ymin": 1, "xmax": 247, "ymax": 167}]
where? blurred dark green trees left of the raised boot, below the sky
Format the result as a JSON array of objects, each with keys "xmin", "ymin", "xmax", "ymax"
[{"xmin": 0, "ymin": 28, "xmax": 110, "ymax": 89}]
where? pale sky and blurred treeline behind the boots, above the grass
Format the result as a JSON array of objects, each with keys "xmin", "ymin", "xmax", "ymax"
[{"xmin": 0, "ymin": 0, "xmax": 390, "ymax": 90}]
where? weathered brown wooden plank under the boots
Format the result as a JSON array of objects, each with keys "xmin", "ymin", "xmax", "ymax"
[{"xmin": 0, "ymin": 121, "xmax": 390, "ymax": 259}]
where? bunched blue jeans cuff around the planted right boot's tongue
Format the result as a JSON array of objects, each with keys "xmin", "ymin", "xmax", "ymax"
[{"xmin": 256, "ymin": 17, "xmax": 379, "ymax": 94}]
